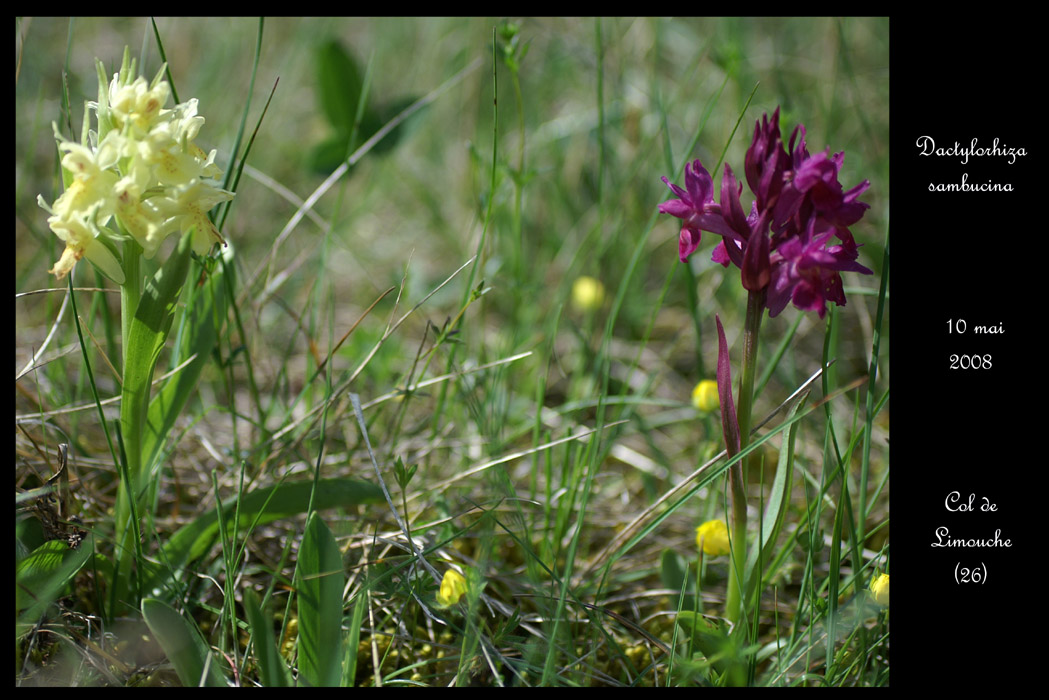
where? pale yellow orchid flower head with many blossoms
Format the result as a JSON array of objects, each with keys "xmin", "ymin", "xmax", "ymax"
[{"xmin": 38, "ymin": 49, "xmax": 233, "ymax": 284}]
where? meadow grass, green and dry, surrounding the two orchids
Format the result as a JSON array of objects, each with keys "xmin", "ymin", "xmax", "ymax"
[{"xmin": 15, "ymin": 18, "xmax": 890, "ymax": 686}]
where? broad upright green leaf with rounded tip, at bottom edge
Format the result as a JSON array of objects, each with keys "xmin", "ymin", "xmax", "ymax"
[{"xmin": 295, "ymin": 512, "xmax": 346, "ymax": 686}]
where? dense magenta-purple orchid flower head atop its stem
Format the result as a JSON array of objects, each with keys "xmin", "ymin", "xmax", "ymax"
[{"xmin": 659, "ymin": 108, "xmax": 873, "ymax": 318}]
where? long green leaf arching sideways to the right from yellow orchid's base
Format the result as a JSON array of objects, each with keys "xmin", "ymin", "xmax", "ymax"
[{"xmin": 143, "ymin": 479, "xmax": 383, "ymax": 591}]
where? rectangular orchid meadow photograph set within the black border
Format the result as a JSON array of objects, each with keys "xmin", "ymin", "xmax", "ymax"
[{"xmin": 15, "ymin": 18, "xmax": 893, "ymax": 687}]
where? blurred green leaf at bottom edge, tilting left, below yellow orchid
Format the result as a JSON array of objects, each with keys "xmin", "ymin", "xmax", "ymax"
[{"xmin": 142, "ymin": 598, "xmax": 226, "ymax": 687}]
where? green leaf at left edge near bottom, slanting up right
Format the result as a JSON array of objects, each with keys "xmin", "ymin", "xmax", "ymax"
[{"xmin": 15, "ymin": 534, "xmax": 94, "ymax": 634}]
